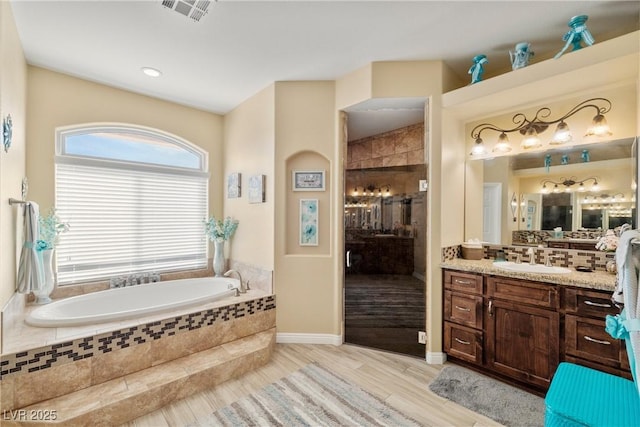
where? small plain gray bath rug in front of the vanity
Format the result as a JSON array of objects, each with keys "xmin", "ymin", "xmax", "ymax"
[{"xmin": 429, "ymin": 366, "xmax": 545, "ymax": 427}]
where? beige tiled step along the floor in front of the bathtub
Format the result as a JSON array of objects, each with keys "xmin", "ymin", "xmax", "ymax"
[{"xmin": 11, "ymin": 328, "xmax": 275, "ymax": 426}]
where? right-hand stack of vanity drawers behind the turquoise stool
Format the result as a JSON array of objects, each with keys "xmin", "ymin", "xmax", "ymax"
[{"xmin": 563, "ymin": 287, "xmax": 630, "ymax": 378}]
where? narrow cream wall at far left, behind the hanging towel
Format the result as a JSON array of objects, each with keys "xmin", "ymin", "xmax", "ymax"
[{"xmin": 0, "ymin": 1, "xmax": 27, "ymax": 312}]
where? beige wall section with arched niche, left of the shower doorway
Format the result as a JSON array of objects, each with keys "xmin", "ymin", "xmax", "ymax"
[{"xmin": 274, "ymin": 81, "xmax": 342, "ymax": 335}]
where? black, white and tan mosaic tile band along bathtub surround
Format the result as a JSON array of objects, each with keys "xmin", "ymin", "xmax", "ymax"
[{"xmin": 0, "ymin": 295, "xmax": 276, "ymax": 381}]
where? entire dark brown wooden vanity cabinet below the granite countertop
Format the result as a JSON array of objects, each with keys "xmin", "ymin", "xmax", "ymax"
[{"xmin": 443, "ymin": 269, "xmax": 631, "ymax": 390}]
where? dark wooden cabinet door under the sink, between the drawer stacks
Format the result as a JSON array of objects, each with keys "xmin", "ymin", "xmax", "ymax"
[{"xmin": 485, "ymin": 299, "xmax": 560, "ymax": 389}]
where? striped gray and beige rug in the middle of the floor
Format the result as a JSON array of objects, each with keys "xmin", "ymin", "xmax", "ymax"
[{"xmin": 193, "ymin": 363, "xmax": 420, "ymax": 427}]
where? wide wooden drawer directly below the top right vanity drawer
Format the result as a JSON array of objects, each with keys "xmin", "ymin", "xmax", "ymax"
[{"xmin": 565, "ymin": 314, "xmax": 626, "ymax": 367}]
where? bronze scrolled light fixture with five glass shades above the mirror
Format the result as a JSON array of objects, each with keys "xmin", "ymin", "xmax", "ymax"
[{"xmin": 471, "ymin": 98, "xmax": 611, "ymax": 156}]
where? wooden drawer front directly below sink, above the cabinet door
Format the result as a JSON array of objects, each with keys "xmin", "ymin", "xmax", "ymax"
[{"xmin": 487, "ymin": 277, "xmax": 558, "ymax": 308}]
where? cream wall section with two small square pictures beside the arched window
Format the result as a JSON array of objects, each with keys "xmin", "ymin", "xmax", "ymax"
[{"xmin": 224, "ymin": 85, "xmax": 280, "ymax": 270}]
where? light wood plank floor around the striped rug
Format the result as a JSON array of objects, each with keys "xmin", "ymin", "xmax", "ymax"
[{"xmin": 120, "ymin": 344, "xmax": 500, "ymax": 427}]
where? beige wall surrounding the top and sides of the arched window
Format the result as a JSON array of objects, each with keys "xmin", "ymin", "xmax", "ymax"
[{"xmin": 27, "ymin": 66, "xmax": 222, "ymax": 214}]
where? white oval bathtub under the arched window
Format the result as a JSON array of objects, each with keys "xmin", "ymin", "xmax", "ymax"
[{"xmin": 25, "ymin": 277, "xmax": 240, "ymax": 328}]
